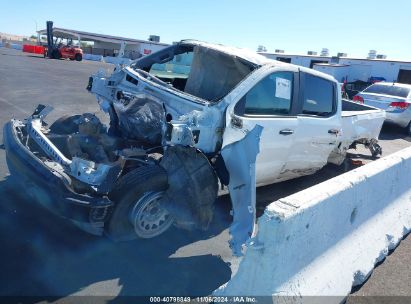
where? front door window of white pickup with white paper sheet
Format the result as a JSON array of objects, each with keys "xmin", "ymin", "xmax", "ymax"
[{"xmin": 236, "ymin": 72, "xmax": 294, "ymax": 116}]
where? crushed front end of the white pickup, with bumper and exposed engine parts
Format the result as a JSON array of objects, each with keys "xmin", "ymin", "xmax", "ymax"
[{"xmin": 3, "ymin": 105, "xmax": 164, "ymax": 235}]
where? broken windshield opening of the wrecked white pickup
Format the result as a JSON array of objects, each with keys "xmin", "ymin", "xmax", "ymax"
[{"xmin": 131, "ymin": 44, "xmax": 255, "ymax": 102}]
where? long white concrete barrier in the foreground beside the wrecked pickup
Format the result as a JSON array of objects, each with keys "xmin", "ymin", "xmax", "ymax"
[{"xmin": 214, "ymin": 148, "xmax": 411, "ymax": 303}]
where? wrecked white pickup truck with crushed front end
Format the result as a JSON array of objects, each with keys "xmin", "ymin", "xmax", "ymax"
[{"xmin": 4, "ymin": 40, "xmax": 385, "ymax": 254}]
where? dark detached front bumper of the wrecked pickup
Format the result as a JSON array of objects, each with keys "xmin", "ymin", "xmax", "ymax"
[{"xmin": 3, "ymin": 120, "xmax": 113, "ymax": 235}]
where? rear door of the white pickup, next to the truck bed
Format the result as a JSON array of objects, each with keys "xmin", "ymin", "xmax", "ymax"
[{"xmin": 281, "ymin": 72, "xmax": 342, "ymax": 178}]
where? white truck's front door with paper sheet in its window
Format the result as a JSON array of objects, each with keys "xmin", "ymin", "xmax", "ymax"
[{"xmin": 223, "ymin": 71, "xmax": 298, "ymax": 186}]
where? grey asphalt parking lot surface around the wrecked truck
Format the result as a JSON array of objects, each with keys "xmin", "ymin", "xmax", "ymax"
[{"xmin": 0, "ymin": 48, "xmax": 411, "ymax": 303}]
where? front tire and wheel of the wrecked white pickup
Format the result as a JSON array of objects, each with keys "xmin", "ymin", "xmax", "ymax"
[{"xmin": 105, "ymin": 165, "xmax": 174, "ymax": 241}]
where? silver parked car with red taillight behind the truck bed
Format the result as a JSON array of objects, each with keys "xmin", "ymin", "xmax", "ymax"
[{"xmin": 353, "ymin": 82, "xmax": 411, "ymax": 135}]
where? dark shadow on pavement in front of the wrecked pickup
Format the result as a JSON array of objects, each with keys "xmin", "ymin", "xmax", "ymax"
[{"xmin": 0, "ymin": 177, "xmax": 231, "ymax": 301}]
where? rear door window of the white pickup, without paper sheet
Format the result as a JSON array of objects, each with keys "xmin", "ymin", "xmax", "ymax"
[{"xmin": 301, "ymin": 73, "xmax": 336, "ymax": 117}]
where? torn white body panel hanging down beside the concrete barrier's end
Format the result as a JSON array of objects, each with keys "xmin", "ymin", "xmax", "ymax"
[{"xmin": 221, "ymin": 125, "xmax": 263, "ymax": 256}]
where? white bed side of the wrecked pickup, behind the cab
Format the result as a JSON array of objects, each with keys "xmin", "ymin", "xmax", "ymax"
[{"xmin": 341, "ymin": 99, "xmax": 385, "ymax": 142}]
